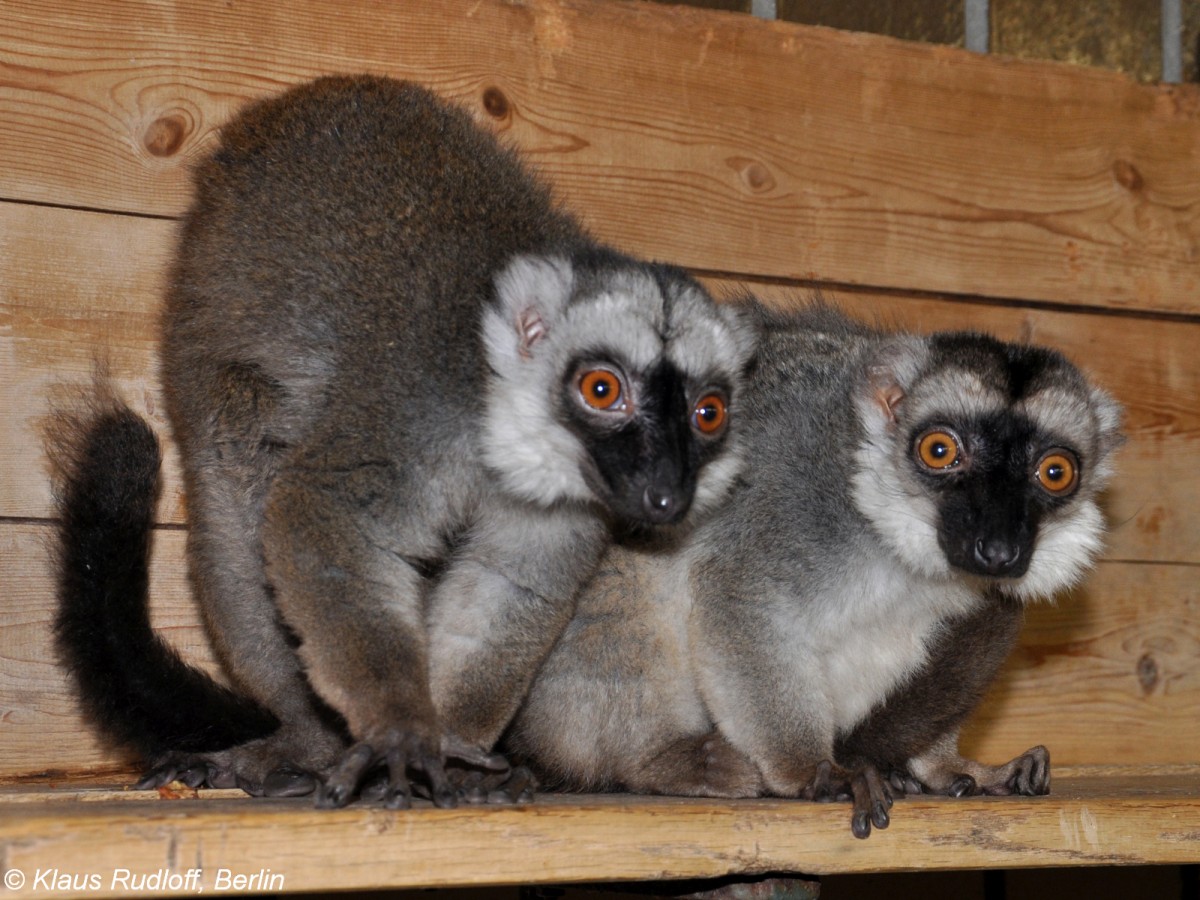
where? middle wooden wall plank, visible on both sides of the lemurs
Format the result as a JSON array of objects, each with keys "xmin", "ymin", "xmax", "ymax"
[{"xmin": 7, "ymin": 203, "xmax": 1200, "ymax": 563}]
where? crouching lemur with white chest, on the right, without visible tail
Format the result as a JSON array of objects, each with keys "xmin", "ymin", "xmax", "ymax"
[{"xmin": 503, "ymin": 305, "xmax": 1121, "ymax": 836}]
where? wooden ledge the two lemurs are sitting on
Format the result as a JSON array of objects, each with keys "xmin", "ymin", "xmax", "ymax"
[{"xmin": 0, "ymin": 766, "xmax": 1200, "ymax": 898}]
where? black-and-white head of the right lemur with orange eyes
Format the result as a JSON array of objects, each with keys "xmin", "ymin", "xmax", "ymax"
[{"xmin": 857, "ymin": 334, "xmax": 1120, "ymax": 599}]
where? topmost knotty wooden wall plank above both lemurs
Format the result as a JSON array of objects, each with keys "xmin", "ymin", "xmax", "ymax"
[{"xmin": 0, "ymin": 0, "xmax": 1200, "ymax": 313}]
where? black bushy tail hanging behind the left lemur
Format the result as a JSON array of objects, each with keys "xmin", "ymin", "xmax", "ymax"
[{"xmin": 48, "ymin": 384, "xmax": 278, "ymax": 762}]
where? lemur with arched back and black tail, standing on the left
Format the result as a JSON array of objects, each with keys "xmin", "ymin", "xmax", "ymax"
[{"xmin": 50, "ymin": 77, "xmax": 755, "ymax": 806}]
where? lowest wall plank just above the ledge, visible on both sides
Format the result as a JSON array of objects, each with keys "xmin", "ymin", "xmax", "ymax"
[{"xmin": 0, "ymin": 523, "xmax": 1200, "ymax": 775}]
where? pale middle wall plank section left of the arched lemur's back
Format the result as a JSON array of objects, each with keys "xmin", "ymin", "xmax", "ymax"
[{"xmin": 0, "ymin": 203, "xmax": 182, "ymax": 521}]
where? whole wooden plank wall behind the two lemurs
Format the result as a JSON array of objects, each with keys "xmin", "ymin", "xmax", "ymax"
[{"xmin": 0, "ymin": 0, "xmax": 1200, "ymax": 774}]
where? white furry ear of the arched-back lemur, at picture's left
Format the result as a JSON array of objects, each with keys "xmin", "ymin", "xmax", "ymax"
[{"xmin": 488, "ymin": 256, "xmax": 575, "ymax": 359}]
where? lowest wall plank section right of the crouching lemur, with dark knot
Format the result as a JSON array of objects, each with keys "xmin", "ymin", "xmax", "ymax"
[{"xmin": 961, "ymin": 563, "xmax": 1200, "ymax": 763}]
